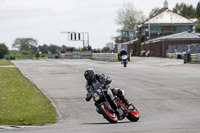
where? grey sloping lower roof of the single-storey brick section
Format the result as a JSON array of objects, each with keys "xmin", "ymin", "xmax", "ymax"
[{"xmin": 142, "ymin": 31, "xmax": 200, "ymax": 45}]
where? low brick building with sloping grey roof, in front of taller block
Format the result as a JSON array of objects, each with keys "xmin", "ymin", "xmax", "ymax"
[{"xmin": 142, "ymin": 31, "xmax": 200, "ymax": 58}]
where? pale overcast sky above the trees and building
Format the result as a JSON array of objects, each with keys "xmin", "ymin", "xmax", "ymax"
[{"xmin": 0, "ymin": 0, "xmax": 199, "ymax": 49}]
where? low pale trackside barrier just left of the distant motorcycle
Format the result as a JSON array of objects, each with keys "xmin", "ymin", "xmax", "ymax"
[{"xmin": 92, "ymin": 53, "xmax": 119, "ymax": 62}]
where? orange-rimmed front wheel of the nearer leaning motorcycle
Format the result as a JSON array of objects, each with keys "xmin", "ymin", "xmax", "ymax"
[{"xmin": 99, "ymin": 104, "xmax": 118, "ymax": 123}]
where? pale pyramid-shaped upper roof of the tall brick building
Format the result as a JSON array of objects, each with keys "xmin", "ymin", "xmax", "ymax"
[{"xmin": 144, "ymin": 9, "xmax": 194, "ymax": 25}]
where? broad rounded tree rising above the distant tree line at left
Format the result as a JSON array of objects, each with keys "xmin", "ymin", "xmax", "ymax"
[{"xmin": 12, "ymin": 38, "xmax": 38, "ymax": 51}]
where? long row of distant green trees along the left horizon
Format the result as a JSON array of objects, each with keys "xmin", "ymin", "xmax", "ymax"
[{"xmin": 0, "ymin": 38, "xmax": 107, "ymax": 59}]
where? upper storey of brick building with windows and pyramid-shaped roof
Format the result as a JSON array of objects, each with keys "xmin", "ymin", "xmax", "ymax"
[{"xmin": 140, "ymin": 5, "xmax": 195, "ymax": 41}]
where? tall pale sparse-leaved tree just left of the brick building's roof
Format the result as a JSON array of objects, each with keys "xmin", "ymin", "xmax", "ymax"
[{"xmin": 115, "ymin": 3, "xmax": 144, "ymax": 29}]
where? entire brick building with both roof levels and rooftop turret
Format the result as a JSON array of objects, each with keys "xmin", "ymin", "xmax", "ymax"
[{"xmin": 140, "ymin": 1, "xmax": 200, "ymax": 57}]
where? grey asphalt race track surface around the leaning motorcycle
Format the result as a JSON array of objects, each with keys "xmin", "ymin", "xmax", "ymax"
[{"xmin": 0, "ymin": 57, "xmax": 200, "ymax": 133}]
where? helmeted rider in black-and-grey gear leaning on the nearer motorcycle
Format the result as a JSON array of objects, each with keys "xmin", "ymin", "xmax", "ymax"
[{"xmin": 84, "ymin": 68, "xmax": 131, "ymax": 111}]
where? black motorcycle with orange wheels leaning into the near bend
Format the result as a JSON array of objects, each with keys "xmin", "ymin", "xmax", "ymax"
[{"xmin": 92, "ymin": 86, "xmax": 140, "ymax": 123}]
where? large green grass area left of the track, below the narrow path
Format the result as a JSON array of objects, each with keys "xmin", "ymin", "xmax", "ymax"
[{"xmin": 0, "ymin": 68, "xmax": 56, "ymax": 125}]
